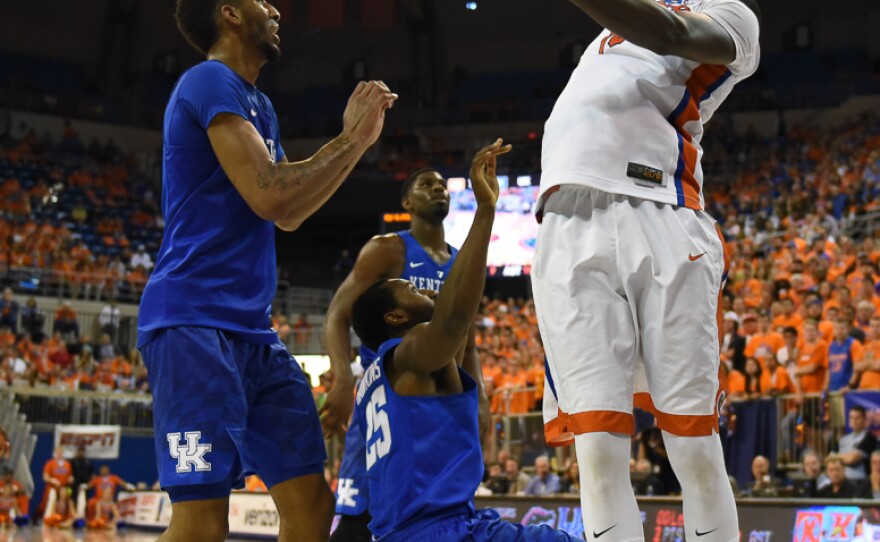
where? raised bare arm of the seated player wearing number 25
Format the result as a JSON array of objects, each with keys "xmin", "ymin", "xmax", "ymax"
[{"xmin": 393, "ymin": 139, "xmax": 511, "ymax": 373}]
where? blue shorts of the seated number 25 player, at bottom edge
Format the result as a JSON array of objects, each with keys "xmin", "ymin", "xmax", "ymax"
[{"xmin": 379, "ymin": 508, "xmax": 582, "ymax": 542}]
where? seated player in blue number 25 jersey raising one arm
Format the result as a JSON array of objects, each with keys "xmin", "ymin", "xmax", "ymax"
[{"xmin": 352, "ymin": 139, "xmax": 575, "ymax": 542}]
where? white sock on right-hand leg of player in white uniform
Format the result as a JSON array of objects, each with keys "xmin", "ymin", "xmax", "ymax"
[{"xmin": 663, "ymin": 431, "xmax": 739, "ymax": 542}]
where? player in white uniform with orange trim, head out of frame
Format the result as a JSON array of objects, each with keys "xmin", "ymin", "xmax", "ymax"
[{"xmin": 532, "ymin": 0, "xmax": 760, "ymax": 542}]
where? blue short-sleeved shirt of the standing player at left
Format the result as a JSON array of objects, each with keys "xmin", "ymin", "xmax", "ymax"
[{"xmin": 138, "ymin": 60, "xmax": 284, "ymax": 347}]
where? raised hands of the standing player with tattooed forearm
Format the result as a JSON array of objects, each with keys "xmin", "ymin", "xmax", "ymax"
[{"xmin": 342, "ymin": 81, "xmax": 397, "ymax": 149}]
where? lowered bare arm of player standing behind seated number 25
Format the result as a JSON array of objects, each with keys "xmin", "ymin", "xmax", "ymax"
[{"xmin": 319, "ymin": 236, "xmax": 406, "ymax": 438}]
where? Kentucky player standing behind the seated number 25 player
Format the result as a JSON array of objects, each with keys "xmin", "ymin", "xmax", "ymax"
[{"xmin": 321, "ymin": 169, "xmax": 489, "ymax": 542}]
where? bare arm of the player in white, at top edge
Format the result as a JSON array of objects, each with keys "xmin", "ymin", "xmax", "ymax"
[{"xmin": 571, "ymin": 0, "xmax": 736, "ymax": 65}]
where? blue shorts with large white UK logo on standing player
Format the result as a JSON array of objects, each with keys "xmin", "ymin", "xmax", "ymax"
[{"xmin": 141, "ymin": 327, "xmax": 327, "ymax": 502}]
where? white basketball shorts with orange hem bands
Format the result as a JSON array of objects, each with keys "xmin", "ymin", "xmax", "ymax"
[{"xmin": 532, "ymin": 185, "xmax": 728, "ymax": 445}]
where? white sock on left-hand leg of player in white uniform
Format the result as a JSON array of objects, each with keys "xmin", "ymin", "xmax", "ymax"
[{"xmin": 574, "ymin": 433, "xmax": 644, "ymax": 542}]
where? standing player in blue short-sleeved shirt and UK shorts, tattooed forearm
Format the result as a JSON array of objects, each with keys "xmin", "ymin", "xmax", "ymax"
[{"xmin": 138, "ymin": 0, "xmax": 396, "ymax": 542}]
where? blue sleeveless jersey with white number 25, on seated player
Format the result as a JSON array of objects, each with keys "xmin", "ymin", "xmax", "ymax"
[{"xmin": 355, "ymin": 339, "xmax": 483, "ymax": 539}]
